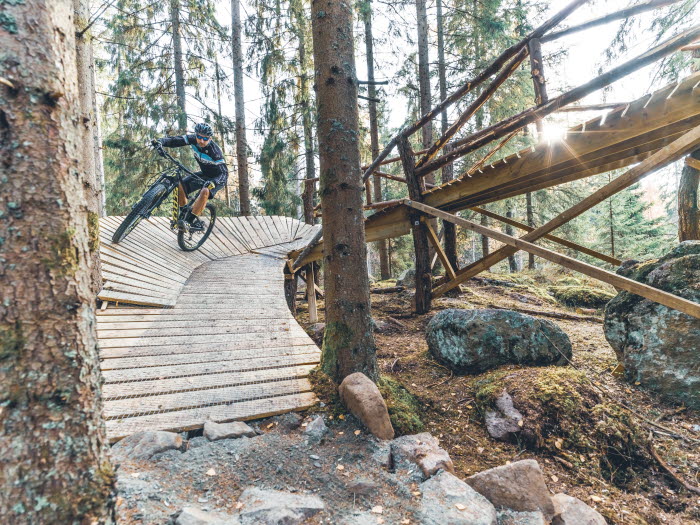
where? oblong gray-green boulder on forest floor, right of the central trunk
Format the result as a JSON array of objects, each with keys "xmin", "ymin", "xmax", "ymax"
[{"xmin": 426, "ymin": 309, "xmax": 571, "ymax": 374}]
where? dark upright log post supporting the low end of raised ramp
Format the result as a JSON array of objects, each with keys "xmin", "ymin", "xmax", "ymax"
[{"xmin": 398, "ymin": 137, "xmax": 432, "ymax": 314}]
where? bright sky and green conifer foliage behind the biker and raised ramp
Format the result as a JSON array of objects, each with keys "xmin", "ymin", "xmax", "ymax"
[{"xmin": 91, "ymin": 0, "xmax": 700, "ymax": 276}]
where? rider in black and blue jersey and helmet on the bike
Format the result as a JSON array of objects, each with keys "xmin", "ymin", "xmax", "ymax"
[{"xmin": 151, "ymin": 122, "xmax": 228, "ymax": 228}]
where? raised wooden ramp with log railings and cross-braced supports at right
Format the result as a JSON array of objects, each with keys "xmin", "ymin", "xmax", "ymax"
[{"xmin": 288, "ymin": 0, "xmax": 700, "ymax": 318}]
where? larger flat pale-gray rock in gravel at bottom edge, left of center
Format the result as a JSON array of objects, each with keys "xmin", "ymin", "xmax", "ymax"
[{"xmin": 238, "ymin": 487, "xmax": 325, "ymax": 525}]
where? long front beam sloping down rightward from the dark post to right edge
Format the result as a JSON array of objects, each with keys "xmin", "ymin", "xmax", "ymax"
[{"xmin": 406, "ymin": 201, "xmax": 700, "ymax": 319}]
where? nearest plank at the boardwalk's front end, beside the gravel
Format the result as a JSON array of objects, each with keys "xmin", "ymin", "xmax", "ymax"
[{"xmin": 106, "ymin": 392, "xmax": 317, "ymax": 442}]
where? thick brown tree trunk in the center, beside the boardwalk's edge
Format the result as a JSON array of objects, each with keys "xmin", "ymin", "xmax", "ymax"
[{"xmin": 311, "ymin": 0, "xmax": 378, "ymax": 382}]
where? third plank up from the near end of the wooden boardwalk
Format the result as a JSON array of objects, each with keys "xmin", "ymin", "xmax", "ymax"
[{"xmin": 102, "ymin": 364, "xmax": 316, "ymax": 398}]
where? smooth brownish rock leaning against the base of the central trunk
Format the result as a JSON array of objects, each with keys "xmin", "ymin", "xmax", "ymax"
[{"xmin": 338, "ymin": 372, "xmax": 394, "ymax": 439}]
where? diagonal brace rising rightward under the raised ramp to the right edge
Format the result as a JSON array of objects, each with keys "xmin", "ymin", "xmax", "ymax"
[{"xmin": 433, "ymin": 126, "xmax": 700, "ymax": 297}]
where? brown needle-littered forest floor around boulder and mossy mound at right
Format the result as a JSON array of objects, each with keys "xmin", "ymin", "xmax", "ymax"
[{"xmin": 297, "ymin": 274, "xmax": 700, "ymax": 525}]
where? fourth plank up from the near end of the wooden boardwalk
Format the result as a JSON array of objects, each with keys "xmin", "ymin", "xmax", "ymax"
[{"xmin": 102, "ymin": 349, "xmax": 321, "ymax": 384}]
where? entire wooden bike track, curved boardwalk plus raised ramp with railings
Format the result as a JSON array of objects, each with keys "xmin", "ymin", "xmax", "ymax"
[{"xmin": 97, "ymin": 4, "xmax": 700, "ymax": 440}]
